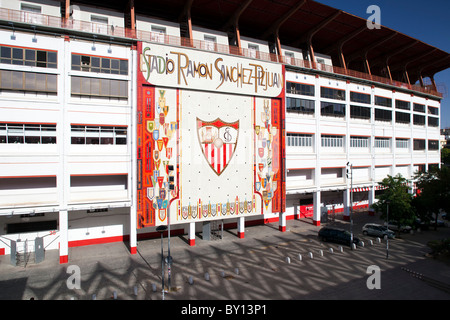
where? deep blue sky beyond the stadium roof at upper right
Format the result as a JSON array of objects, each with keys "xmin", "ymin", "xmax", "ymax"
[{"xmin": 316, "ymin": 0, "xmax": 450, "ymax": 128}]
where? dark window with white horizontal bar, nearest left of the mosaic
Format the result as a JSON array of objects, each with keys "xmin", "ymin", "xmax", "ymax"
[{"xmin": 71, "ymin": 125, "xmax": 127, "ymax": 145}]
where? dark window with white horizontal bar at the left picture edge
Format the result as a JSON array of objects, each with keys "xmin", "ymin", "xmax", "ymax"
[{"xmin": 0, "ymin": 123, "xmax": 56, "ymax": 144}]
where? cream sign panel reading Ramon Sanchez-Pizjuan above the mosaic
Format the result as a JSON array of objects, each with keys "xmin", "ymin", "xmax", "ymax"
[{"xmin": 139, "ymin": 44, "xmax": 284, "ymax": 97}]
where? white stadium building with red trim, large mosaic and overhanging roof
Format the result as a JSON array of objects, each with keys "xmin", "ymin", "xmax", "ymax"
[{"xmin": 0, "ymin": 0, "xmax": 450, "ymax": 264}]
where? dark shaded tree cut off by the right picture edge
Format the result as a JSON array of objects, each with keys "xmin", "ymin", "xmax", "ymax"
[{"xmin": 413, "ymin": 166, "xmax": 450, "ymax": 230}]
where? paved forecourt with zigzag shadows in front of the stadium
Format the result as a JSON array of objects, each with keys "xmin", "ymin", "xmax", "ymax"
[{"xmin": 0, "ymin": 212, "xmax": 450, "ymax": 302}]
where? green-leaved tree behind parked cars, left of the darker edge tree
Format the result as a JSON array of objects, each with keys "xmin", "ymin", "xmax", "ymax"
[{"xmin": 372, "ymin": 174, "xmax": 415, "ymax": 230}]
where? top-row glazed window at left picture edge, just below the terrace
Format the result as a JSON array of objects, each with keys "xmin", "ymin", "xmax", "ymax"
[{"xmin": 0, "ymin": 46, "xmax": 57, "ymax": 69}]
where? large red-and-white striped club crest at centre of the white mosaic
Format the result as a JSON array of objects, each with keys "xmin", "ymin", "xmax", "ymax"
[{"xmin": 197, "ymin": 118, "xmax": 239, "ymax": 176}]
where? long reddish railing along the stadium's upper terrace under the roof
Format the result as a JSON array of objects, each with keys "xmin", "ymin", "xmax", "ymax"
[{"xmin": 0, "ymin": 8, "xmax": 443, "ymax": 98}]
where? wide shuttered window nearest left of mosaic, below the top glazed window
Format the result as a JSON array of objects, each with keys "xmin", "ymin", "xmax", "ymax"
[{"xmin": 71, "ymin": 76, "xmax": 128, "ymax": 99}]
